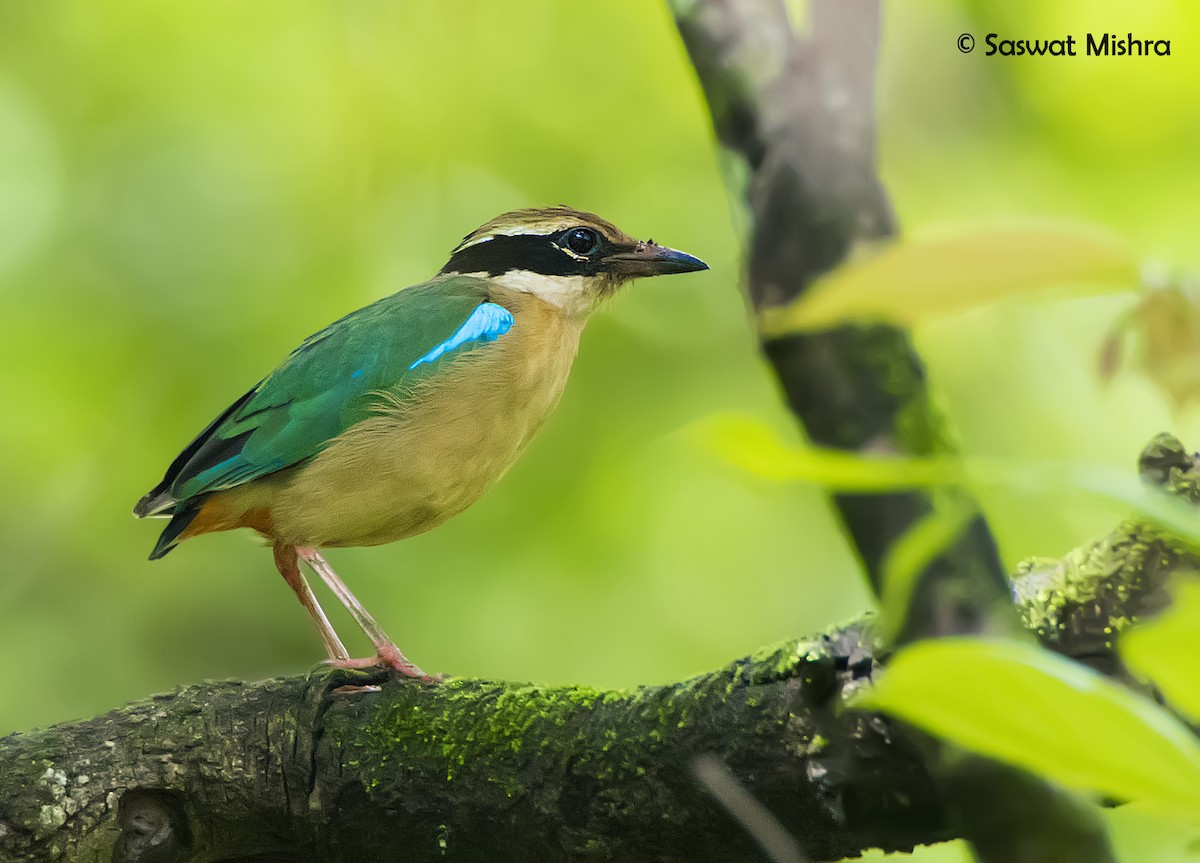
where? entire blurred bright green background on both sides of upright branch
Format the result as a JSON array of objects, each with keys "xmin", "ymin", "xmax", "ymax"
[{"xmin": 0, "ymin": 0, "xmax": 1200, "ymax": 861}]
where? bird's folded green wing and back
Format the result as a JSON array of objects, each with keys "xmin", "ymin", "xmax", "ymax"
[{"xmin": 150, "ymin": 276, "xmax": 496, "ymax": 513}]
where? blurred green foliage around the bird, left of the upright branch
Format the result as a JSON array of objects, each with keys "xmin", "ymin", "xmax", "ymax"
[{"xmin": 0, "ymin": 0, "xmax": 864, "ymax": 730}]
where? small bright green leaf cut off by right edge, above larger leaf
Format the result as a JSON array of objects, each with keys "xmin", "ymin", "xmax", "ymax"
[{"xmin": 1118, "ymin": 580, "xmax": 1200, "ymax": 720}]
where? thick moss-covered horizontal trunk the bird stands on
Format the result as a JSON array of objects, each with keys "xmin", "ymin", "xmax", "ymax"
[{"xmin": 0, "ymin": 438, "xmax": 1200, "ymax": 863}]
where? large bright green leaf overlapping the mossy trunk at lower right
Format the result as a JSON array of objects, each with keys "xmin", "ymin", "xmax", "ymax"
[{"xmin": 852, "ymin": 639, "xmax": 1200, "ymax": 820}]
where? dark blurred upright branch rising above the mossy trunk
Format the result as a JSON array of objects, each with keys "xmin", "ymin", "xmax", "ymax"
[{"xmin": 672, "ymin": 0, "xmax": 1015, "ymax": 639}]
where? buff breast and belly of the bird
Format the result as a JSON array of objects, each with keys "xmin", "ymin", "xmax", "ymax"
[{"xmin": 271, "ymin": 295, "xmax": 580, "ymax": 546}]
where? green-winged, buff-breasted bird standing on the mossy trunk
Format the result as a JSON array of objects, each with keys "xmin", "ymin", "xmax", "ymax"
[{"xmin": 133, "ymin": 206, "xmax": 708, "ymax": 681}]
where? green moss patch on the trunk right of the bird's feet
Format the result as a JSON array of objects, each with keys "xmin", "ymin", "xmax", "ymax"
[{"xmin": 353, "ymin": 640, "xmax": 828, "ymax": 805}]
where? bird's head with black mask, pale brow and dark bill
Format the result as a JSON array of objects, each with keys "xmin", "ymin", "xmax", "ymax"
[{"xmin": 442, "ymin": 206, "xmax": 708, "ymax": 316}]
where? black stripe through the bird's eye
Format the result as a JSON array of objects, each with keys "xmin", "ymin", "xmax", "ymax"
[{"xmin": 442, "ymin": 228, "xmax": 607, "ymax": 276}]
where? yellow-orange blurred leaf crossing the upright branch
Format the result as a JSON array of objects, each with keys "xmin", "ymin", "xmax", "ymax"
[{"xmin": 760, "ymin": 227, "xmax": 1139, "ymax": 336}]
